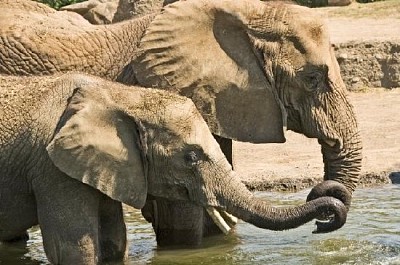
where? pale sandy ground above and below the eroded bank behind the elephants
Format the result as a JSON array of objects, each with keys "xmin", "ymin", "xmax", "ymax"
[{"xmin": 234, "ymin": 13, "xmax": 400, "ymax": 190}]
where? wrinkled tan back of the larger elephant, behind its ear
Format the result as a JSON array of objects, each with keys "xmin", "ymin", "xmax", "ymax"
[{"xmin": 0, "ymin": 0, "xmax": 154, "ymax": 81}]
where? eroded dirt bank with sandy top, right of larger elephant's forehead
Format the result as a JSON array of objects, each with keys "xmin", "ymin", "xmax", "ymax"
[{"xmin": 326, "ymin": 17, "xmax": 400, "ymax": 91}]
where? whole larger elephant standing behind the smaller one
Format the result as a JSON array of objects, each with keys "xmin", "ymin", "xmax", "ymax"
[{"xmin": 0, "ymin": 0, "xmax": 362, "ymax": 245}]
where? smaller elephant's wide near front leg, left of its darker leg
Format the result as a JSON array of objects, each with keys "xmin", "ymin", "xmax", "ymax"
[{"xmin": 32, "ymin": 174, "xmax": 101, "ymax": 265}]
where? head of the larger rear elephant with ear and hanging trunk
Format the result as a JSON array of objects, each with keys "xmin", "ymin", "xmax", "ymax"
[{"xmin": 134, "ymin": 0, "xmax": 362, "ymax": 200}]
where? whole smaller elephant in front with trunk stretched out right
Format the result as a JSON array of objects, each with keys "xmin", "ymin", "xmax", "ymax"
[{"xmin": 0, "ymin": 74, "xmax": 347, "ymax": 265}]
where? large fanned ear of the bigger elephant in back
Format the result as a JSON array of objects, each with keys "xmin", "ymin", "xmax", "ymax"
[{"xmin": 134, "ymin": 0, "xmax": 286, "ymax": 143}]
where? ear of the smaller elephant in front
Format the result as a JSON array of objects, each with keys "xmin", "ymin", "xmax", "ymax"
[{"xmin": 47, "ymin": 88, "xmax": 147, "ymax": 208}]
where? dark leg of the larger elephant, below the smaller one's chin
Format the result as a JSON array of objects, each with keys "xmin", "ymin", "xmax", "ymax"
[{"xmin": 142, "ymin": 198, "xmax": 204, "ymax": 247}]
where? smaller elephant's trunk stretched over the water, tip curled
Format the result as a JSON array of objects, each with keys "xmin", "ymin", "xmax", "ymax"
[{"xmin": 216, "ymin": 173, "xmax": 347, "ymax": 233}]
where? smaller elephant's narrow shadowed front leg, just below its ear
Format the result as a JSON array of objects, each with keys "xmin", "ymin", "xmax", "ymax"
[{"xmin": 99, "ymin": 195, "xmax": 127, "ymax": 262}]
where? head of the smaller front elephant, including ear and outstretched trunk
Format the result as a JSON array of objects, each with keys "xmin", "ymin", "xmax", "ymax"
[{"xmin": 47, "ymin": 75, "xmax": 347, "ymax": 236}]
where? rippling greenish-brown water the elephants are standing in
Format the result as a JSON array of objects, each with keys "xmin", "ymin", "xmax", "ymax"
[{"xmin": 0, "ymin": 185, "xmax": 400, "ymax": 265}]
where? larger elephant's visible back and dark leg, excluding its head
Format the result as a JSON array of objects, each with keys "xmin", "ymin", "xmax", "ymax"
[{"xmin": 0, "ymin": 0, "xmax": 220, "ymax": 246}]
